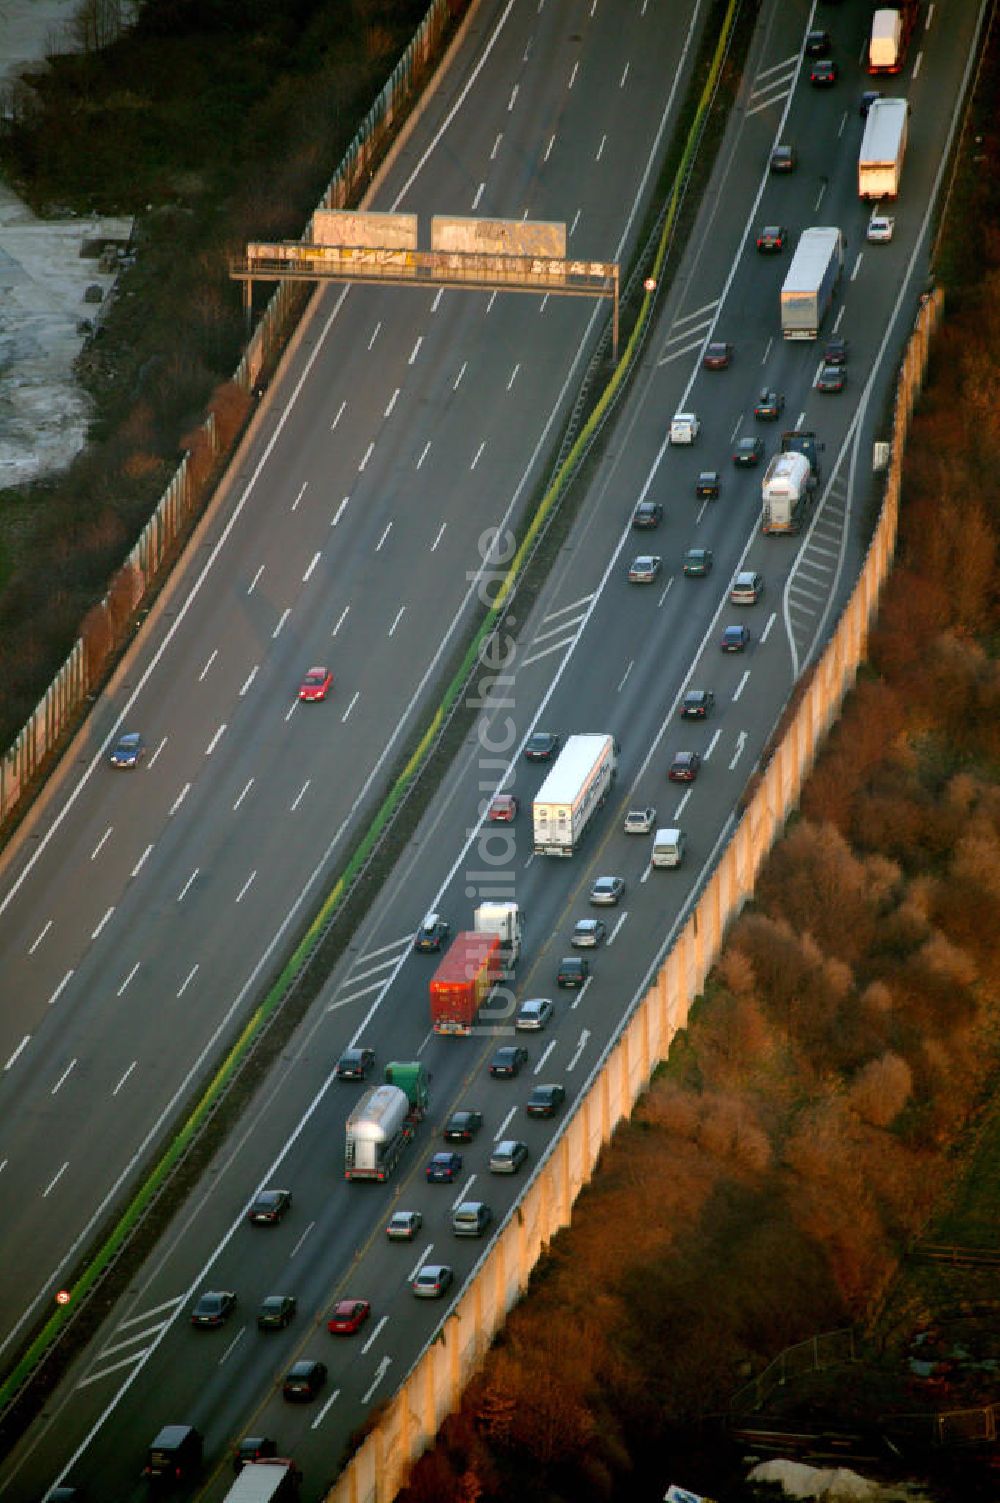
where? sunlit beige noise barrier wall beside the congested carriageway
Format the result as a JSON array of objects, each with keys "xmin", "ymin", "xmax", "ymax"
[{"xmin": 326, "ymin": 293, "xmax": 943, "ymax": 1503}]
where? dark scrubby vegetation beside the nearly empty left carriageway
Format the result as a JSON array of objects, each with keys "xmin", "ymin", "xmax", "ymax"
[{"xmin": 0, "ymin": 0, "xmax": 426, "ymax": 747}]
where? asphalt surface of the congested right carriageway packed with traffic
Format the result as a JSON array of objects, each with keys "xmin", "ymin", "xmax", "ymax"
[{"xmin": 0, "ymin": 6, "xmax": 977, "ymax": 1498}]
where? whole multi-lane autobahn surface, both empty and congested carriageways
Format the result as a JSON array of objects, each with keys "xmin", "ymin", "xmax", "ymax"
[{"xmin": 0, "ymin": 5, "xmax": 977, "ymax": 1498}]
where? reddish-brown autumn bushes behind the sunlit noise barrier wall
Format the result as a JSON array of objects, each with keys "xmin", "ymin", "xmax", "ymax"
[{"xmin": 390, "ymin": 32, "xmax": 1000, "ymax": 1503}]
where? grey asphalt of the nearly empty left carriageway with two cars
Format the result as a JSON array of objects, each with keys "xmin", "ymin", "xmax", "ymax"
[{"xmin": 0, "ymin": 3, "xmax": 700, "ymax": 1354}]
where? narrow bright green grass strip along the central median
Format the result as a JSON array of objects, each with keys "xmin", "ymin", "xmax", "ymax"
[{"xmin": 0, "ymin": 0, "xmax": 740, "ymax": 1411}]
